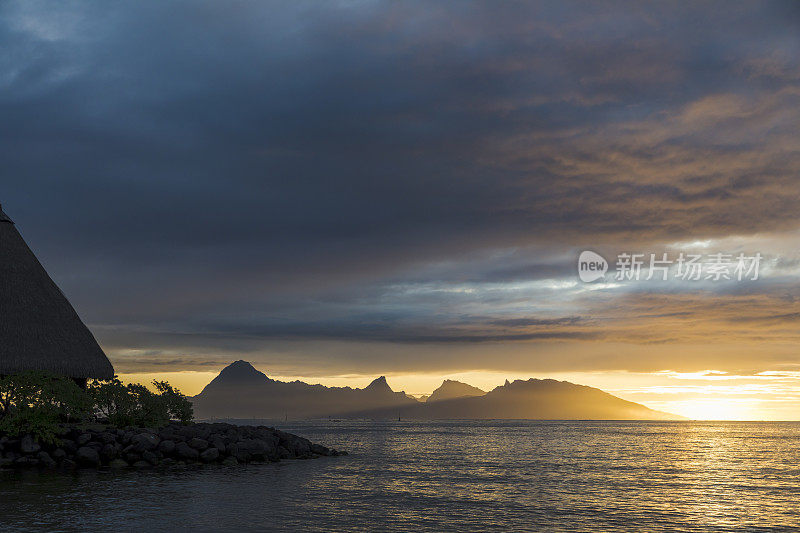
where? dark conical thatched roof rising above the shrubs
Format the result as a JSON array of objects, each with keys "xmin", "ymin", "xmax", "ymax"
[{"xmin": 0, "ymin": 204, "xmax": 114, "ymax": 379}]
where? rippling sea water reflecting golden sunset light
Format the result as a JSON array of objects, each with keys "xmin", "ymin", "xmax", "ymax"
[{"xmin": 0, "ymin": 421, "xmax": 800, "ymax": 532}]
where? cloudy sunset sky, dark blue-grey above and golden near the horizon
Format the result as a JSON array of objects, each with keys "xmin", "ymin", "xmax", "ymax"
[{"xmin": 0, "ymin": 0, "xmax": 800, "ymax": 419}]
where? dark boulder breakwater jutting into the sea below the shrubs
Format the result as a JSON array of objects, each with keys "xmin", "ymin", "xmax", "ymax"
[{"xmin": 0, "ymin": 423, "xmax": 346, "ymax": 469}]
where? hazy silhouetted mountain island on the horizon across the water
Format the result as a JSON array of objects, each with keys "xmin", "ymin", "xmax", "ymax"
[{"xmin": 192, "ymin": 361, "xmax": 682, "ymax": 420}]
